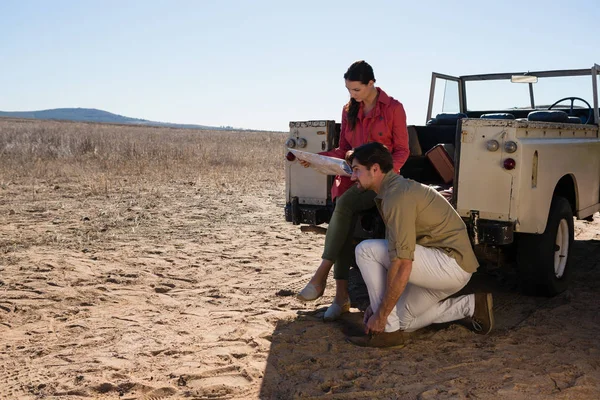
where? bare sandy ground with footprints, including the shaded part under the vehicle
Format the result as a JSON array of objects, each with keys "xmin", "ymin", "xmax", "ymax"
[{"xmin": 0, "ymin": 182, "xmax": 600, "ymax": 400}]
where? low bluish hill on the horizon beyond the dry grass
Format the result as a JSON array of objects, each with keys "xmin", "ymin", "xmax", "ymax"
[{"xmin": 0, "ymin": 108, "xmax": 239, "ymax": 130}]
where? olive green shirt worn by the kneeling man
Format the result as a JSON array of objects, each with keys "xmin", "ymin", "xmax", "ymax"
[{"xmin": 375, "ymin": 171, "xmax": 479, "ymax": 273}]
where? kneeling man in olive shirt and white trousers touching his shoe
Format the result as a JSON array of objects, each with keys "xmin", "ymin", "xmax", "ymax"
[{"xmin": 347, "ymin": 142, "xmax": 494, "ymax": 347}]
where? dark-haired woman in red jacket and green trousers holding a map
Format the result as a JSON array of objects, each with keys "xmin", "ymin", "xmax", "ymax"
[{"xmin": 297, "ymin": 61, "xmax": 409, "ymax": 321}]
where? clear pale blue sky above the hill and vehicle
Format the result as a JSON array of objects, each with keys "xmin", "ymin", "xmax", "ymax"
[{"xmin": 0, "ymin": 0, "xmax": 600, "ymax": 131}]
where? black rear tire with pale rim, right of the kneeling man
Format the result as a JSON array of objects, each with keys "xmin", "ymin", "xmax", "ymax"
[{"xmin": 517, "ymin": 196, "xmax": 574, "ymax": 296}]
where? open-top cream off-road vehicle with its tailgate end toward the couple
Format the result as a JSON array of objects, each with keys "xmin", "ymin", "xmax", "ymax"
[{"xmin": 285, "ymin": 64, "xmax": 600, "ymax": 295}]
